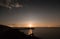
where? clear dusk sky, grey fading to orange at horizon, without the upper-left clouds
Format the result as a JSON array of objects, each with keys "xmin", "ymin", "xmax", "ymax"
[{"xmin": 0, "ymin": 0, "xmax": 60, "ymax": 27}]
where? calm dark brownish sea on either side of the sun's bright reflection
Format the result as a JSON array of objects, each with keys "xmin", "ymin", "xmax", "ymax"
[{"xmin": 21, "ymin": 27, "xmax": 60, "ymax": 39}]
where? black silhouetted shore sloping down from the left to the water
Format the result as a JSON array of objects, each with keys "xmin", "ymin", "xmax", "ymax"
[{"xmin": 0, "ymin": 25, "xmax": 39, "ymax": 39}]
